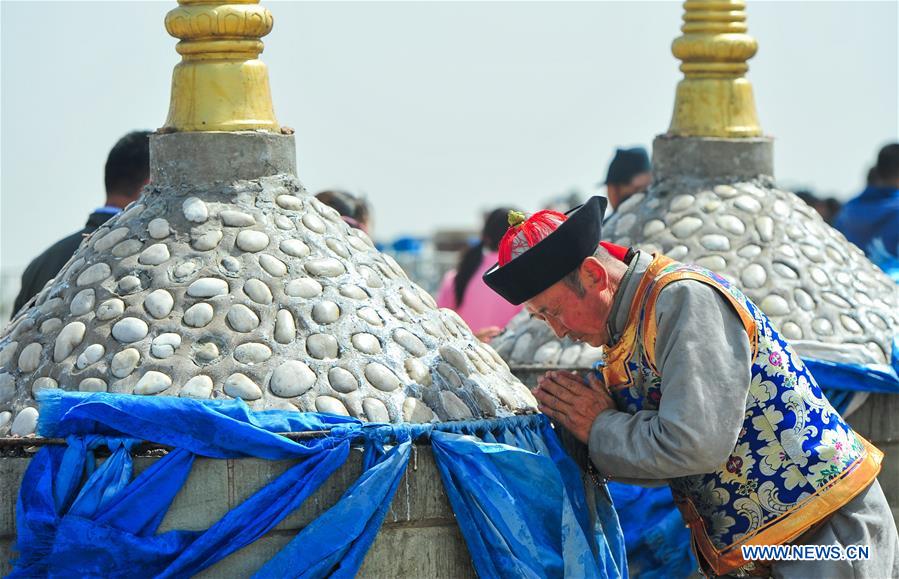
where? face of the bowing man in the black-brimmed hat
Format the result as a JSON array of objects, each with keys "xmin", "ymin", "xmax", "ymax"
[{"xmin": 525, "ymin": 258, "xmax": 613, "ymax": 346}]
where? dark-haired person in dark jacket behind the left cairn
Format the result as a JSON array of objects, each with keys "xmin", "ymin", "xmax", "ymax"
[{"xmin": 13, "ymin": 131, "xmax": 150, "ymax": 315}]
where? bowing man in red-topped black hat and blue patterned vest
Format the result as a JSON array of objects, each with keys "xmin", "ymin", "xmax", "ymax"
[{"xmin": 484, "ymin": 197, "xmax": 899, "ymax": 577}]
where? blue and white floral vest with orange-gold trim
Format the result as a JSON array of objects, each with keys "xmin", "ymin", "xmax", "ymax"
[{"xmin": 603, "ymin": 256, "xmax": 883, "ymax": 575}]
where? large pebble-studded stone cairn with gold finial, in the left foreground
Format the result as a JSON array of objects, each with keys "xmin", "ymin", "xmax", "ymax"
[{"xmin": 0, "ymin": 0, "xmax": 536, "ymax": 436}]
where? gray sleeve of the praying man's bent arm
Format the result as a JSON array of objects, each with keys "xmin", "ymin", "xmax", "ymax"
[{"xmin": 589, "ymin": 280, "xmax": 751, "ymax": 479}]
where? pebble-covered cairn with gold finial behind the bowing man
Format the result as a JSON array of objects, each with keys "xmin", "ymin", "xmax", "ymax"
[{"xmin": 493, "ymin": 0, "xmax": 899, "ymax": 398}]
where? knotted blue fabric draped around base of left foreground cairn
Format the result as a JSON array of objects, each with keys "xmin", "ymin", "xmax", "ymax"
[{"xmin": 12, "ymin": 391, "xmax": 627, "ymax": 577}]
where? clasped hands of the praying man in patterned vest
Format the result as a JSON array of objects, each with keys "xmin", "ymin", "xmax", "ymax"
[{"xmin": 534, "ymin": 370, "xmax": 615, "ymax": 444}]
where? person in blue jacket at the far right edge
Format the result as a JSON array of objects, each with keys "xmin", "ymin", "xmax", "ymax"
[{"xmin": 834, "ymin": 143, "xmax": 899, "ymax": 281}]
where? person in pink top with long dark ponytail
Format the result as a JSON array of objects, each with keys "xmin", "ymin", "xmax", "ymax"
[{"xmin": 437, "ymin": 207, "xmax": 521, "ymax": 342}]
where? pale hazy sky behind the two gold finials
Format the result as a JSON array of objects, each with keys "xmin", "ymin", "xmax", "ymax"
[{"xmin": 0, "ymin": 0, "xmax": 899, "ymax": 271}]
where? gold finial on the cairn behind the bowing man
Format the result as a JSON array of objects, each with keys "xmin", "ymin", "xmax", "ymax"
[{"xmin": 668, "ymin": 0, "xmax": 762, "ymax": 138}]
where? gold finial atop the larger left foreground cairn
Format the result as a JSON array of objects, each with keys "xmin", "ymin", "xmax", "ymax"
[{"xmin": 164, "ymin": 0, "xmax": 279, "ymax": 132}]
